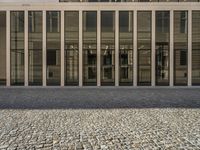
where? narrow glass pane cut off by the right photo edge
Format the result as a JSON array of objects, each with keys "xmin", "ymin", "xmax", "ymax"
[{"xmin": 192, "ymin": 11, "xmax": 200, "ymax": 85}]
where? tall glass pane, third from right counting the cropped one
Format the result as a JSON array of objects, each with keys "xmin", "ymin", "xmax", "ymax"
[{"xmin": 155, "ymin": 11, "xmax": 170, "ymax": 85}]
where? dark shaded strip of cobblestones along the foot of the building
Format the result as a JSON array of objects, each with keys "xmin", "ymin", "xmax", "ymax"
[{"xmin": 0, "ymin": 87, "xmax": 200, "ymax": 109}]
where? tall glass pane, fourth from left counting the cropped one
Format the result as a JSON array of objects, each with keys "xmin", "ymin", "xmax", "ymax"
[{"xmin": 47, "ymin": 11, "xmax": 60, "ymax": 85}]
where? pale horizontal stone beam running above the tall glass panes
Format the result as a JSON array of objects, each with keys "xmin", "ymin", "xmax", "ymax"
[{"xmin": 0, "ymin": 2, "xmax": 200, "ymax": 10}]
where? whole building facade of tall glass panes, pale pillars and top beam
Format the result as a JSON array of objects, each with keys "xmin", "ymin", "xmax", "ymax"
[{"xmin": 0, "ymin": 0, "xmax": 200, "ymax": 86}]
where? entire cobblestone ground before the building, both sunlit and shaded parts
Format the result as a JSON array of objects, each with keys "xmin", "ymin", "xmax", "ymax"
[{"xmin": 0, "ymin": 88, "xmax": 200, "ymax": 150}]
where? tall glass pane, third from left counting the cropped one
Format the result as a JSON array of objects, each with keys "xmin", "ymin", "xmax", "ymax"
[{"xmin": 28, "ymin": 11, "xmax": 42, "ymax": 85}]
